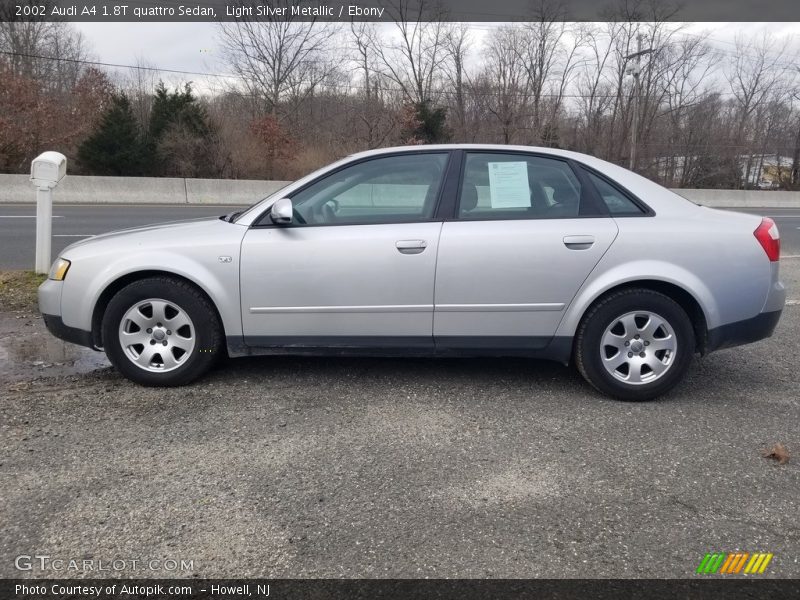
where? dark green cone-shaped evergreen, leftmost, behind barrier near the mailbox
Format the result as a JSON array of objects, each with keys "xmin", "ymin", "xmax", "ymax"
[{"xmin": 78, "ymin": 94, "xmax": 146, "ymax": 175}]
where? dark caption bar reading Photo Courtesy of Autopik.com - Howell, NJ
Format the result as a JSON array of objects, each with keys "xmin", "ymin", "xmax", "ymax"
[{"xmin": 0, "ymin": 576, "xmax": 800, "ymax": 600}]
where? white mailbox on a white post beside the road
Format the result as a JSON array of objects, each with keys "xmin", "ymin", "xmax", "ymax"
[{"xmin": 31, "ymin": 152, "xmax": 67, "ymax": 274}]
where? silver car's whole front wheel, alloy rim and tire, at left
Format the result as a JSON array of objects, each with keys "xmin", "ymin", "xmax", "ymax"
[{"xmin": 102, "ymin": 277, "xmax": 222, "ymax": 386}]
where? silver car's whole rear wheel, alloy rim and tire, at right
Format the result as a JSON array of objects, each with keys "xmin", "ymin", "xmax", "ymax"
[{"xmin": 575, "ymin": 289, "xmax": 695, "ymax": 401}]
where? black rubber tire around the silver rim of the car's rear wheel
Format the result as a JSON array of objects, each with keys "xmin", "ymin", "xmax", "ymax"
[{"xmin": 574, "ymin": 288, "xmax": 695, "ymax": 402}]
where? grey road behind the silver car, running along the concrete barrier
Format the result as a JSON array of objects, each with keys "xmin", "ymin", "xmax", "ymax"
[{"xmin": 0, "ymin": 204, "xmax": 800, "ymax": 269}]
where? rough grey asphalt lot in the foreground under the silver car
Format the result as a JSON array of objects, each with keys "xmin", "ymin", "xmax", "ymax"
[{"xmin": 0, "ymin": 258, "xmax": 800, "ymax": 580}]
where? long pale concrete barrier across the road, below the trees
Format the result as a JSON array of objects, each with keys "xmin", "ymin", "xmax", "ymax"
[{"xmin": 0, "ymin": 174, "xmax": 800, "ymax": 208}]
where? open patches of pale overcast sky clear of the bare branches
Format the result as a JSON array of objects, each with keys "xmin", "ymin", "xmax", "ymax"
[{"xmin": 75, "ymin": 23, "xmax": 800, "ymax": 87}]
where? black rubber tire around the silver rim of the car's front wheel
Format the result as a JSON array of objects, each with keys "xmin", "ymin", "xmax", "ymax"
[{"xmin": 102, "ymin": 277, "xmax": 224, "ymax": 387}]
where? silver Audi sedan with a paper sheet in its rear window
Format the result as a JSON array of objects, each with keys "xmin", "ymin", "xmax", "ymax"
[{"xmin": 39, "ymin": 145, "xmax": 785, "ymax": 400}]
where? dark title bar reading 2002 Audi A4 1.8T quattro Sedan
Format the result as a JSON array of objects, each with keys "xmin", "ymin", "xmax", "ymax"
[{"xmin": 0, "ymin": 0, "xmax": 800, "ymax": 22}]
